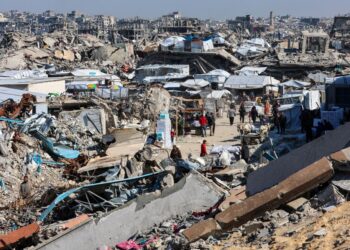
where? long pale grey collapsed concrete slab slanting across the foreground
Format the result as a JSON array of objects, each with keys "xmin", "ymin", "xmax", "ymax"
[{"xmin": 37, "ymin": 173, "xmax": 223, "ymax": 249}]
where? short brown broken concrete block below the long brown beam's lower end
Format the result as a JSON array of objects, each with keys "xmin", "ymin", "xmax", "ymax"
[{"xmin": 182, "ymin": 218, "xmax": 220, "ymax": 242}]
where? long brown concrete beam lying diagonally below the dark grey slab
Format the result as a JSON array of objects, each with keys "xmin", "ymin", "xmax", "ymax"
[{"xmin": 215, "ymin": 158, "xmax": 333, "ymax": 229}]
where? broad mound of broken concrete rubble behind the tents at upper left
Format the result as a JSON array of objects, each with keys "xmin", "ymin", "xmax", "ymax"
[{"xmin": 0, "ymin": 32, "xmax": 135, "ymax": 73}]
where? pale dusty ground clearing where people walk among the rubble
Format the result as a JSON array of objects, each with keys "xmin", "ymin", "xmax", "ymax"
[{"xmin": 177, "ymin": 115, "xmax": 239, "ymax": 158}]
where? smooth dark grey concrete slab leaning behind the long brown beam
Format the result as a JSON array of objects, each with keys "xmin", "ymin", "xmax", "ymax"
[{"xmin": 247, "ymin": 123, "xmax": 350, "ymax": 196}]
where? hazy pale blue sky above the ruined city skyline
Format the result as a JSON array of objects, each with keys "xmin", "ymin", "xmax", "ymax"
[{"xmin": 0, "ymin": 0, "xmax": 350, "ymax": 20}]
